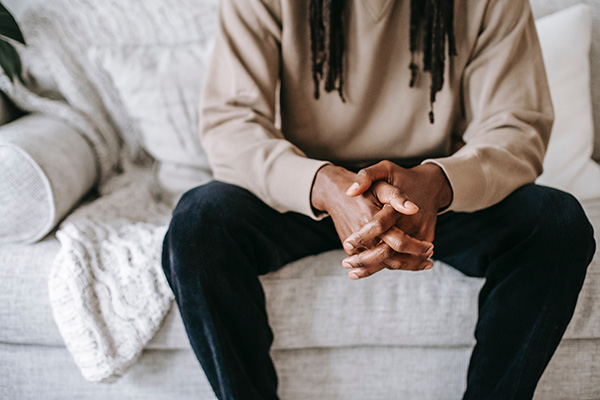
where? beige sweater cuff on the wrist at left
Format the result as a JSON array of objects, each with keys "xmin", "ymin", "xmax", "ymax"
[{"xmin": 269, "ymin": 155, "xmax": 330, "ymax": 220}]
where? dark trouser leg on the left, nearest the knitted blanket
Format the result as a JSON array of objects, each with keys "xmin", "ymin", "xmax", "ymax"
[{"xmin": 162, "ymin": 182, "xmax": 341, "ymax": 400}]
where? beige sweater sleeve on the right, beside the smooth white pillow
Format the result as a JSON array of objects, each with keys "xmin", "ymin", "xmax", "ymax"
[{"xmin": 424, "ymin": 0, "xmax": 554, "ymax": 212}]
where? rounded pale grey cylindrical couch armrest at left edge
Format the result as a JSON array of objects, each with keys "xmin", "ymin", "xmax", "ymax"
[{"xmin": 0, "ymin": 114, "xmax": 97, "ymax": 243}]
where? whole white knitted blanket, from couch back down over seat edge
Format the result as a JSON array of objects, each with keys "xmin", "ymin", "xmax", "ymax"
[{"xmin": 0, "ymin": 0, "xmax": 220, "ymax": 382}]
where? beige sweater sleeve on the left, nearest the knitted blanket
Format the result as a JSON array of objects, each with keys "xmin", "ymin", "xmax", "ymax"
[{"xmin": 200, "ymin": 0, "xmax": 326, "ymax": 219}]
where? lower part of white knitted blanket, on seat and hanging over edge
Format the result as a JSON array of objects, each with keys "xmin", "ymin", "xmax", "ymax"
[{"xmin": 48, "ymin": 166, "xmax": 172, "ymax": 382}]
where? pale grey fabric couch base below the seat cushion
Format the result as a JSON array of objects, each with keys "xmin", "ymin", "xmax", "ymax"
[{"xmin": 0, "ymin": 340, "xmax": 600, "ymax": 400}]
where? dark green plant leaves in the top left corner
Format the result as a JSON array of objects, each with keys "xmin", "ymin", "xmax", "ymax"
[{"xmin": 0, "ymin": 3, "xmax": 25, "ymax": 82}]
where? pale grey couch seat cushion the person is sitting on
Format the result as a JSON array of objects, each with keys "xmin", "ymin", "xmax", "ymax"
[{"xmin": 0, "ymin": 199, "xmax": 600, "ymax": 350}]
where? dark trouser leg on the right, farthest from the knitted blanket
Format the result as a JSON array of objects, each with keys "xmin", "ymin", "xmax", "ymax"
[{"xmin": 434, "ymin": 185, "xmax": 595, "ymax": 400}]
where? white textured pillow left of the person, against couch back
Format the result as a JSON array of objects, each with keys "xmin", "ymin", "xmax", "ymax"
[{"xmin": 89, "ymin": 41, "xmax": 213, "ymax": 200}]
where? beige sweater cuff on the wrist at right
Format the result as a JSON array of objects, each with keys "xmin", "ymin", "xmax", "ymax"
[{"xmin": 422, "ymin": 153, "xmax": 488, "ymax": 212}]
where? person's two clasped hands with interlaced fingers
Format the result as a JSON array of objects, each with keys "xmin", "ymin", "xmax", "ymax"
[{"xmin": 311, "ymin": 161, "xmax": 452, "ymax": 279}]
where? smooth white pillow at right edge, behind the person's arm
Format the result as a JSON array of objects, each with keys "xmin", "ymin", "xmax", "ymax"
[{"xmin": 537, "ymin": 4, "xmax": 600, "ymax": 200}]
